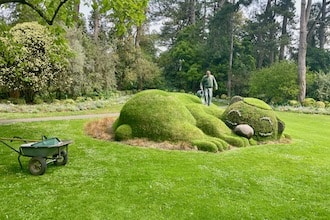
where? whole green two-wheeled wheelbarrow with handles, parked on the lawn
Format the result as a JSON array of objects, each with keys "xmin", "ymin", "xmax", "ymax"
[{"xmin": 0, "ymin": 136, "xmax": 72, "ymax": 175}]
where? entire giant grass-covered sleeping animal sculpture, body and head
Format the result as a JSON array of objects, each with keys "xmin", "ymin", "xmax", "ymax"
[{"xmin": 112, "ymin": 90, "xmax": 280, "ymax": 152}]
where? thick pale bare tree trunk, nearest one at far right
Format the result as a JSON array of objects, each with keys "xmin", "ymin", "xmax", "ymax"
[{"xmin": 298, "ymin": 0, "xmax": 312, "ymax": 103}]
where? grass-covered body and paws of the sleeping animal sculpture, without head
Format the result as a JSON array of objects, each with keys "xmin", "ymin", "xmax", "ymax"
[{"xmin": 113, "ymin": 90, "xmax": 249, "ymax": 152}]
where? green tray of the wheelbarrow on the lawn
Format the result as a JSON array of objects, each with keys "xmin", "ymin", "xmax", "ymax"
[{"xmin": 20, "ymin": 138, "xmax": 72, "ymax": 157}]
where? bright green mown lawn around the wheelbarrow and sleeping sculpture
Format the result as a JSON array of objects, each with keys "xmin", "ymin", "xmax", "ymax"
[{"xmin": 0, "ymin": 112, "xmax": 330, "ymax": 220}]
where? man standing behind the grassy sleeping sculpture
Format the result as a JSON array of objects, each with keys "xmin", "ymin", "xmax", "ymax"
[{"xmin": 199, "ymin": 70, "xmax": 218, "ymax": 106}]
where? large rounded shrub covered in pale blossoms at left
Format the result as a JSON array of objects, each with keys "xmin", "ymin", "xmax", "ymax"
[{"xmin": 0, "ymin": 22, "xmax": 70, "ymax": 102}]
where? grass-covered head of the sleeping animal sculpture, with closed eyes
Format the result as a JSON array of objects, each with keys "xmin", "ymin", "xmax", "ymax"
[{"xmin": 222, "ymin": 97, "xmax": 285, "ymax": 141}]
